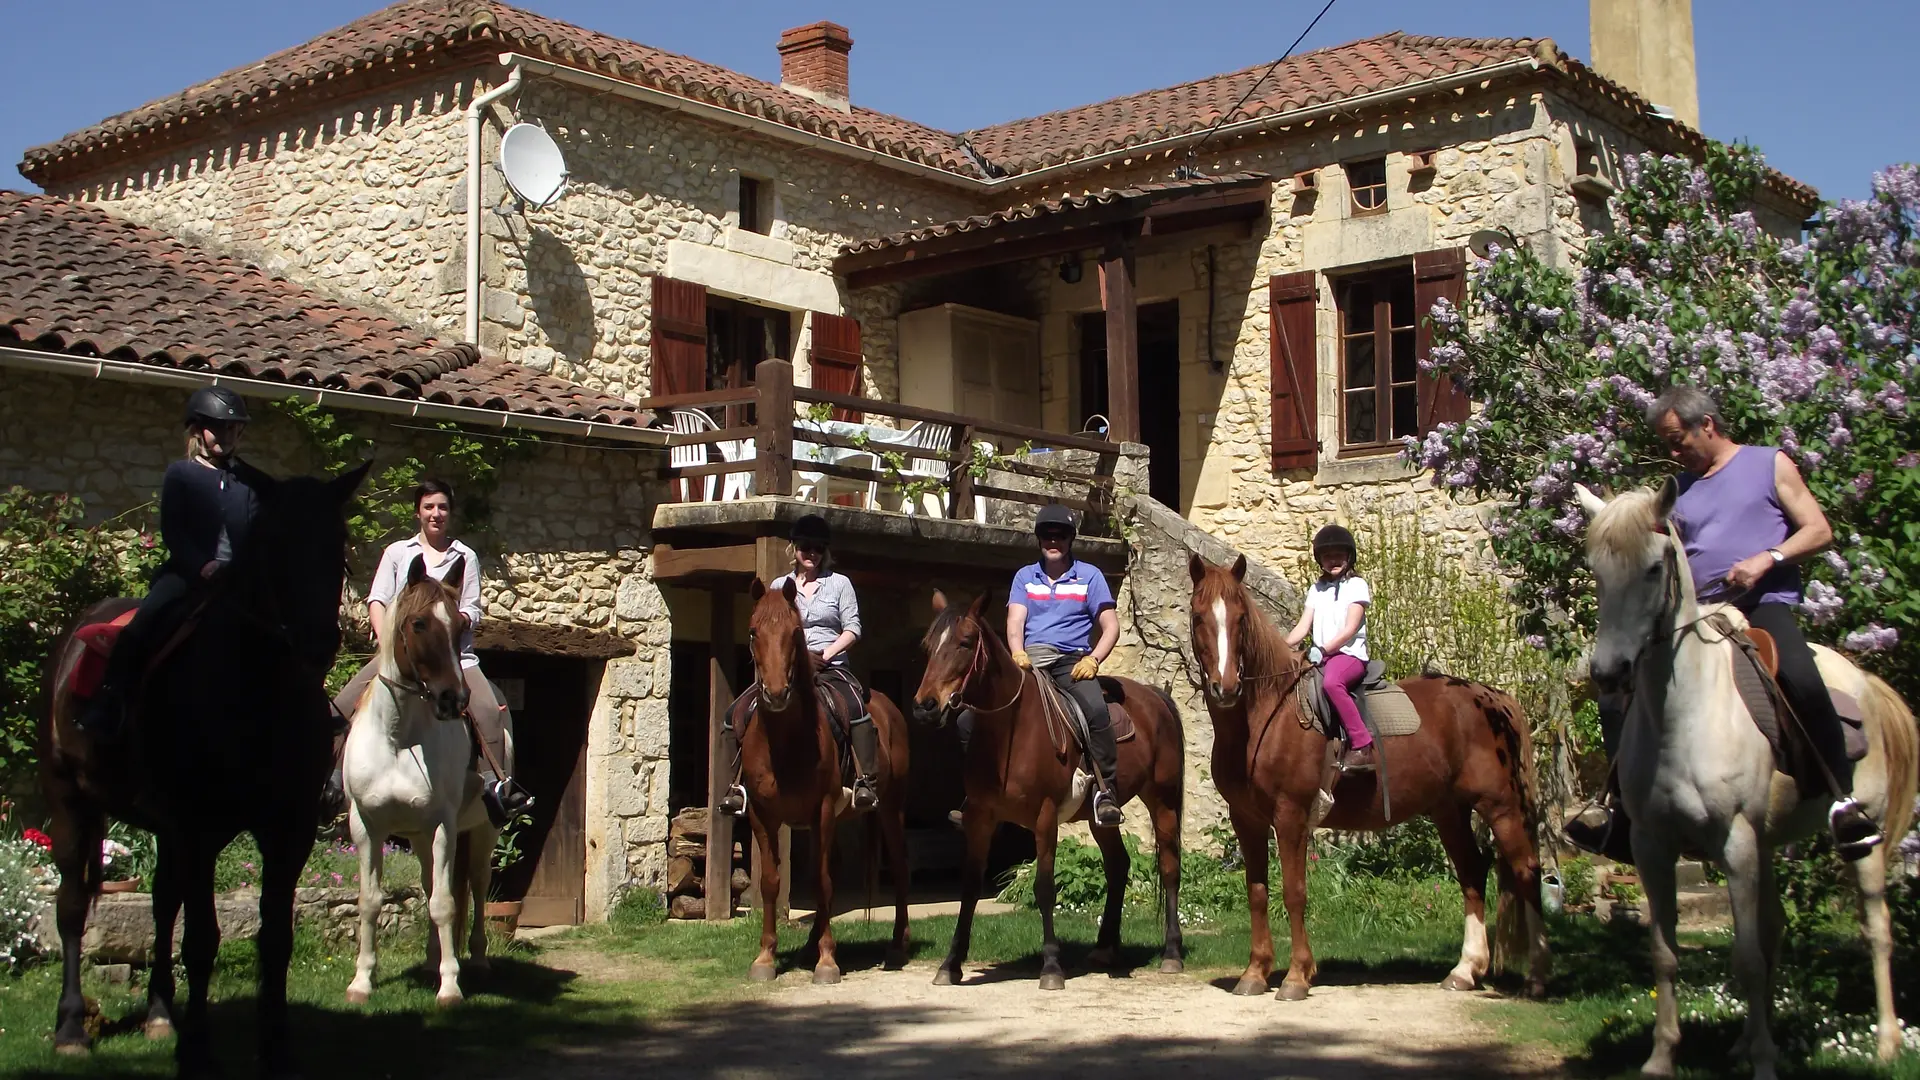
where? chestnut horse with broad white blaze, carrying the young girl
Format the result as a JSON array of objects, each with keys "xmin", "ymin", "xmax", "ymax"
[{"xmin": 1188, "ymin": 555, "xmax": 1548, "ymax": 1001}]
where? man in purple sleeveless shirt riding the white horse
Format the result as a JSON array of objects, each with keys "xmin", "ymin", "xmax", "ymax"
[{"xmin": 1567, "ymin": 386, "xmax": 1882, "ymax": 859}]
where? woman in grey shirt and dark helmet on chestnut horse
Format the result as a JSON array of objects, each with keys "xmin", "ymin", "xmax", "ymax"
[{"xmin": 720, "ymin": 513, "xmax": 879, "ymax": 813}]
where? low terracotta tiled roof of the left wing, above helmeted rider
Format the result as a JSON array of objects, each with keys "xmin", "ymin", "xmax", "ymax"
[{"xmin": 0, "ymin": 192, "xmax": 645, "ymax": 427}]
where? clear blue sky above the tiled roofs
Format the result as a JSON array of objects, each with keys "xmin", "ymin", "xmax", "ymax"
[{"xmin": 0, "ymin": 0, "xmax": 1920, "ymax": 198}]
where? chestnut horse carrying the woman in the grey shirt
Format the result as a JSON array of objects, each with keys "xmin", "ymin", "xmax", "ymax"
[{"xmin": 732, "ymin": 578, "xmax": 908, "ymax": 982}]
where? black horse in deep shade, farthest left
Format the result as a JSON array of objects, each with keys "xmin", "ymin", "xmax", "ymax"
[{"xmin": 38, "ymin": 461, "xmax": 372, "ymax": 1076}]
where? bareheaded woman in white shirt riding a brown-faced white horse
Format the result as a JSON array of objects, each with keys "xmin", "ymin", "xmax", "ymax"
[{"xmin": 326, "ymin": 480, "xmax": 534, "ymax": 826}]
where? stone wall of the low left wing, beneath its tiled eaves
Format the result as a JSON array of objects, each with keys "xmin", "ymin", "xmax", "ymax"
[{"xmin": 0, "ymin": 371, "xmax": 670, "ymax": 915}]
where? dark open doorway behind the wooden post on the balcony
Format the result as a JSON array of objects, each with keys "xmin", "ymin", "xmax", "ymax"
[{"xmin": 1073, "ymin": 300, "xmax": 1185, "ymax": 509}]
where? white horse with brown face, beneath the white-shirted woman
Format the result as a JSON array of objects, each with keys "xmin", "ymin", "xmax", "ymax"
[{"xmin": 342, "ymin": 557, "xmax": 513, "ymax": 1005}]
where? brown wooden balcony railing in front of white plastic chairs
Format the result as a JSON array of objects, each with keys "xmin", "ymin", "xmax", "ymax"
[{"xmin": 636, "ymin": 359, "xmax": 1119, "ymax": 534}]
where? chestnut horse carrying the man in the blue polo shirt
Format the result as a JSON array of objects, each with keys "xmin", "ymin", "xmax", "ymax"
[{"xmin": 914, "ymin": 592, "xmax": 1185, "ymax": 990}]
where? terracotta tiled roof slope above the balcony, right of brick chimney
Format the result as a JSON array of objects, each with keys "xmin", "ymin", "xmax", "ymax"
[{"xmin": 968, "ymin": 31, "xmax": 1557, "ymax": 173}]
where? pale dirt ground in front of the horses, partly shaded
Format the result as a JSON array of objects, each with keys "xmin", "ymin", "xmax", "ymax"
[{"xmin": 518, "ymin": 953, "xmax": 1561, "ymax": 1080}]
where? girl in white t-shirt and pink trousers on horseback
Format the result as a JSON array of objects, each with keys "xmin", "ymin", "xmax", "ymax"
[{"xmin": 1286, "ymin": 525, "xmax": 1373, "ymax": 773}]
